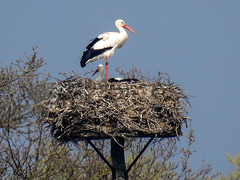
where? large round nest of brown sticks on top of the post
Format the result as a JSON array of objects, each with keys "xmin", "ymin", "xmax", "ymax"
[{"xmin": 47, "ymin": 77, "xmax": 189, "ymax": 141}]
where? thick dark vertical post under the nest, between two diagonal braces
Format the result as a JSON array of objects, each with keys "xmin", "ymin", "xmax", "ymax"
[{"xmin": 111, "ymin": 137, "xmax": 128, "ymax": 180}]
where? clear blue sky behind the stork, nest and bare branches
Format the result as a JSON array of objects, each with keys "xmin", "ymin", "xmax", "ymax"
[{"xmin": 0, "ymin": 0, "xmax": 240, "ymax": 176}]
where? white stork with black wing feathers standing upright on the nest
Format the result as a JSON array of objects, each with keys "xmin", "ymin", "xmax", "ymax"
[{"xmin": 80, "ymin": 19, "xmax": 135, "ymax": 82}]
